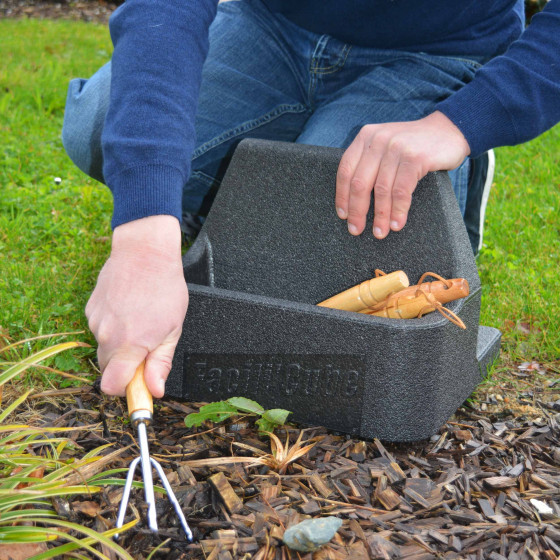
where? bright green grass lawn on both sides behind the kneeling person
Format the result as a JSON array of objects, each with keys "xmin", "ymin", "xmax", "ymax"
[{"xmin": 0, "ymin": 20, "xmax": 560, "ymax": 392}]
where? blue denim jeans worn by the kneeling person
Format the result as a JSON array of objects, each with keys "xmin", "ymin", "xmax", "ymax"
[{"xmin": 62, "ymin": 0, "xmax": 480, "ymax": 225}]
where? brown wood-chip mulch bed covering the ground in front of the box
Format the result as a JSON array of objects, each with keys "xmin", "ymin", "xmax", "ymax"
[{"xmin": 30, "ymin": 380, "xmax": 560, "ymax": 560}]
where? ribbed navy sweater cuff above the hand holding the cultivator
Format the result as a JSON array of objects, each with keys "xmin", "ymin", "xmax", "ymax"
[{"xmin": 107, "ymin": 164, "xmax": 184, "ymax": 229}]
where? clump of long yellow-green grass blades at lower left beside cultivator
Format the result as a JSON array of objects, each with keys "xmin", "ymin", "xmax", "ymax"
[{"xmin": 0, "ymin": 334, "xmax": 137, "ymax": 560}]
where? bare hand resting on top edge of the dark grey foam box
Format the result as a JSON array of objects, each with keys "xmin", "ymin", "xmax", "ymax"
[{"xmin": 335, "ymin": 111, "xmax": 470, "ymax": 239}]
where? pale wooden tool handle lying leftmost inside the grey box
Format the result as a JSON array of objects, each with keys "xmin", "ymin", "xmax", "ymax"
[{"xmin": 317, "ymin": 270, "xmax": 409, "ymax": 311}]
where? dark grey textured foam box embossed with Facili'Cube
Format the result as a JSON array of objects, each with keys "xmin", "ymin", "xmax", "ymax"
[{"xmin": 167, "ymin": 140, "xmax": 500, "ymax": 441}]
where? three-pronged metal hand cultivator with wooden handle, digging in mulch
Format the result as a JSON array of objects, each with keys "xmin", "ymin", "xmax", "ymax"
[{"xmin": 115, "ymin": 363, "xmax": 193, "ymax": 541}]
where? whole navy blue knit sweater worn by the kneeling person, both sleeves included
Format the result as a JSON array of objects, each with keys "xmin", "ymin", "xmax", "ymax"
[{"xmin": 102, "ymin": 0, "xmax": 560, "ymax": 227}]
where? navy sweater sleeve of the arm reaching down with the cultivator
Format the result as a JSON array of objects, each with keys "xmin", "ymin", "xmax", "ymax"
[{"xmin": 102, "ymin": 0, "xmax": 217, "ymax": 228}]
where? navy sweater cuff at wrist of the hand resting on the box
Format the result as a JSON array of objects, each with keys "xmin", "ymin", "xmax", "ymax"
[{"xmin": 435, "ymin": 83, "xmax": 518, "ymax": 158}]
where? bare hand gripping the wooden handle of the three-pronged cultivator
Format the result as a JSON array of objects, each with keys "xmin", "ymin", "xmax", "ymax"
[{"xmin": 86, "ymin": 216, "xmax": 188, "ymax": 398}]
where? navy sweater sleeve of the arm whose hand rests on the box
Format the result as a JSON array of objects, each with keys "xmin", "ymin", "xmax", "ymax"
[{"xmin": 436, "ymin": 0, "xmax": 560, "ymax": 157}]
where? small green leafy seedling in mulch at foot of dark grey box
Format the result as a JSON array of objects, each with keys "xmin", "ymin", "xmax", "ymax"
[{"xmin": 185, "ymin": 397, "xmax": 291, "ymax": 432}]
